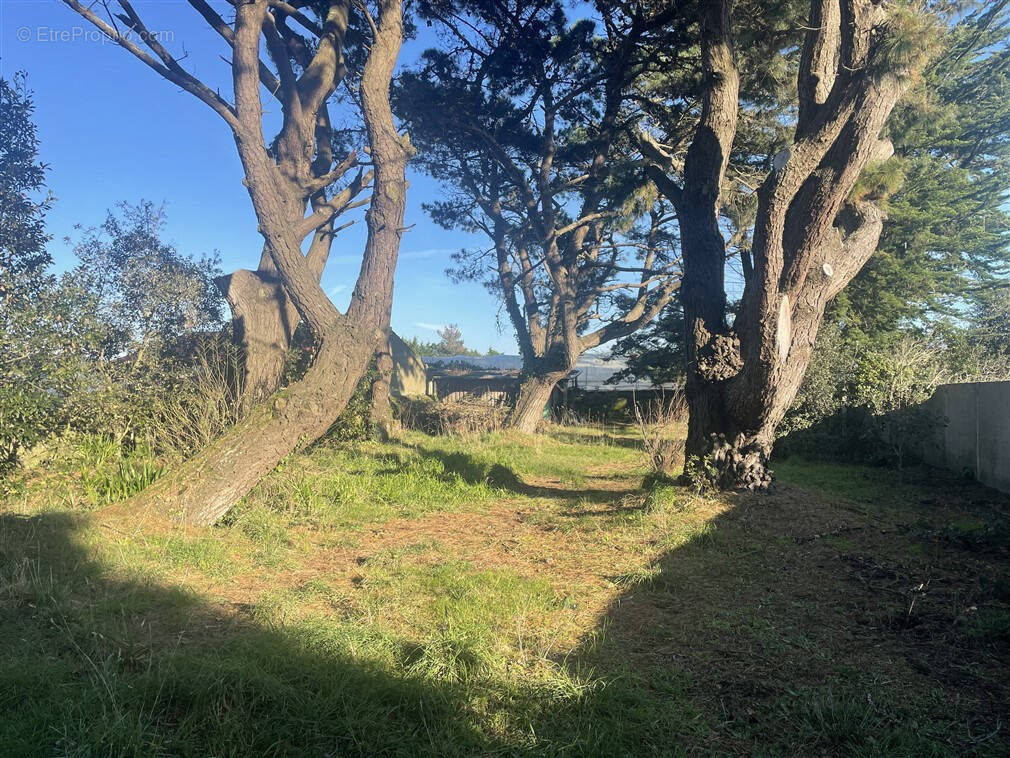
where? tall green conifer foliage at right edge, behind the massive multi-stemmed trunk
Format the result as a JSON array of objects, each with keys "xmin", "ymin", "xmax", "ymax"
[{"xmin": 828, "ymin": 0, "xmax": 1010, "ymax": 345}]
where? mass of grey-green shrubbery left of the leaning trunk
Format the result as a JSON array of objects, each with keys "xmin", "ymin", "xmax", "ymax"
[{"xmin": 0, "ymin": 202, "xmax": 234, "ymax": 475}]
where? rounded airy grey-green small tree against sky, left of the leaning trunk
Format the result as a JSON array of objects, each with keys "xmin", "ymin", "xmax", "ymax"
[{"xmin": 61, "ymin": 201, "xmax": 229, "ymax": 448}]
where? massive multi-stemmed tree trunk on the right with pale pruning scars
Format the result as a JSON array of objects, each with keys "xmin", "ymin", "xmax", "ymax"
[{"xmin": 643, "ymin": 0, "xmax": 933, "ymax": 488}]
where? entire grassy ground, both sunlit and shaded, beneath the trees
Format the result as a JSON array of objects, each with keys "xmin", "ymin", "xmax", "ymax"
[{"xmin": 0, "ymin": 429, "xmax": 1010, "ymax": 756}]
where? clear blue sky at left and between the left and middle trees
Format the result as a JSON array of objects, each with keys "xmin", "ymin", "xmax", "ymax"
[{"xmin": 0, "ymin": 0, "xmax": 516, "ymax": 353}]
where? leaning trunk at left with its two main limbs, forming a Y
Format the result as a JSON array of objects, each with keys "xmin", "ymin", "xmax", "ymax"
[{"xmin": 104, "ymin": 0, "xmax": 412, "ymax": 525}]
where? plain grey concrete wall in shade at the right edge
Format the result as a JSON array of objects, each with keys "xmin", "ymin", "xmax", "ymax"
[{"xmin": 923, "ymin": 382, "xmax": 1010, "ymax": 492}]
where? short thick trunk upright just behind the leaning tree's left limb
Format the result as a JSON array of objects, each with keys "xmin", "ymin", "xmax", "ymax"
[{"xmin": 217, "ymin": 269, "xmax": 299, "ymax": 405}]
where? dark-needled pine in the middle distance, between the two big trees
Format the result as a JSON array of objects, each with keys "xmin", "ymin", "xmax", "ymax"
[{"xmin": 397, "ymin": 0, "xmax": 679, "ymax": 432}]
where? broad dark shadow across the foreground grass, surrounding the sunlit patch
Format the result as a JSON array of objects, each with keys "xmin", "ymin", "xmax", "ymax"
[{"xmin": 0, "ymin": 462, "xmax": 1010, "ymax": 756}]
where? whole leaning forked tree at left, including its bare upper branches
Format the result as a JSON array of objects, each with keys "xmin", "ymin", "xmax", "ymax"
[{"xmin": 64, "ymin": 0, "xmax": 412, "ymax": 524}]
